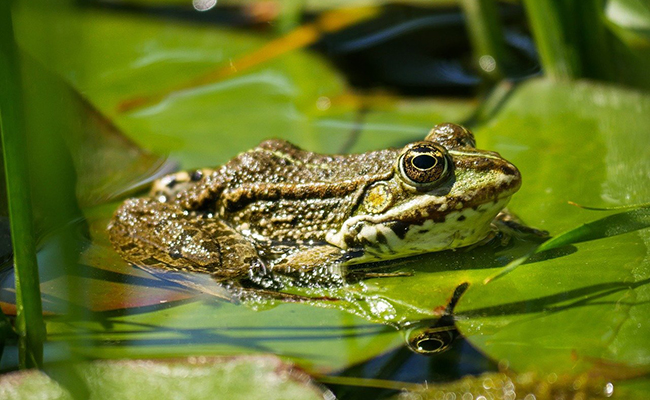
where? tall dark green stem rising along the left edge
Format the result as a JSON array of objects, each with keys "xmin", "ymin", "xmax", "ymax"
[{"xmin": 0, "ymin": 0, "xmax": 45, "ymax": 368}]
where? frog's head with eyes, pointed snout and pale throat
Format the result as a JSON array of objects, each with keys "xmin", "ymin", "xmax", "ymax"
[{"xmin": 327, "ymin": 124, "xmax": 521, "ymax": 260}]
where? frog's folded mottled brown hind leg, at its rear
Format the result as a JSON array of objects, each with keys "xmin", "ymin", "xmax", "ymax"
[{"xmin": 108, "ymin": 198, "xmax": 264, "ymax": 281}]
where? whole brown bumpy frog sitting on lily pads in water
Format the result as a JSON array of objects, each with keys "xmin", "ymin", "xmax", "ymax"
[{"xmin": 108, "ymin": 123, "xmax": 521, "ymax": 298}]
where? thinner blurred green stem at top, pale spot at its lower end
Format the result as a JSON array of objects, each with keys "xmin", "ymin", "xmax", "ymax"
[{"xmin": 460, "ymin": 0, "xmax": 507, "ymax": 81}]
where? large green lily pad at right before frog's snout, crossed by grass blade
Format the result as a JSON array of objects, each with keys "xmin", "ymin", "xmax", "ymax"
[{"xmin": 457, "ymin": 81, "xmax": 650, "ymax": 373}]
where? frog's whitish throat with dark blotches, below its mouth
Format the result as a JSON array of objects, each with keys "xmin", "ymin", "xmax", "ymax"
[{"xmin": 326, "ymin": 196, "xmax": 510, "ymax": 262}]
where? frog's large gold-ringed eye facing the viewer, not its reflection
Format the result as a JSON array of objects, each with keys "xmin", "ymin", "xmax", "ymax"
[{"xmin": 397, "ymin": 142, "xmax": 450, "ymax": 189}]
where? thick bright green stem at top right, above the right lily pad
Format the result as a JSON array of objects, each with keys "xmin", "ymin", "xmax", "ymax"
[{"xmin": 524, "ymin": 0, "xmax": 581, "ymax": 81}]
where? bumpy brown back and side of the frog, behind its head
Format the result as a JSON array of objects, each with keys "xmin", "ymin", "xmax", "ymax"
[{"xmin": 213, "ymin": 140, "xmax": 398, "ymax": 241}]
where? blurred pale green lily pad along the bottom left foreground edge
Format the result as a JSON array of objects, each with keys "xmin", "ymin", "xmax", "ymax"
[{"xmin": 0, "ymin": 356, "xmax": 333, "ymax": 400}]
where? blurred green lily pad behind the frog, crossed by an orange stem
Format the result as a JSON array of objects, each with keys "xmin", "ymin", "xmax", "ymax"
[{"xmin": 16, "ymin": 9, "xmax": 474, "ymax": 168}]
